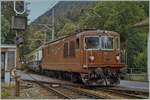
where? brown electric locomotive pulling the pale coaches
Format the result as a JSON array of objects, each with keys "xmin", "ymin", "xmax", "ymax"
[{"xmin": 41, "ymin": 30, "xmax": 126, "ymax": 85}]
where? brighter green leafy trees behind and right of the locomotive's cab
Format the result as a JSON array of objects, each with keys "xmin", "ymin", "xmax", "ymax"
[{"xmin": 79, "ymin": 1, "xmax": 148, "ymax": 67}]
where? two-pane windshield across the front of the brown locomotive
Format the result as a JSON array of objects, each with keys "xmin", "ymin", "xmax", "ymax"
[{"xmin": 85, "ymin": 36, "xmax": 115, "ymax": 50}]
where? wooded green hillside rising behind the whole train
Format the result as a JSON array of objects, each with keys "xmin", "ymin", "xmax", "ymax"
[{"xmin": 2, "ymin": 1, "xmax": 149, "ymax": 69}]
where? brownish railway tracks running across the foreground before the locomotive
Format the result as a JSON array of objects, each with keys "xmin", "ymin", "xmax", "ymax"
[{"xmin": 22, "ymin": 74, "xmax": 148, "ymax": 99}]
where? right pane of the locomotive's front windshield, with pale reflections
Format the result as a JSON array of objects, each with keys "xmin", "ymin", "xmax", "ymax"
[{"xmin": 101, "ymin": 36, "xmax": 113, "ymax": 49}]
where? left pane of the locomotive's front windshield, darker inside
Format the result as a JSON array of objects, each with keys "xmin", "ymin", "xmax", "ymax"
[{"xmin": 85, "ymin": 37, "xmax": 100, "ymax": 49}]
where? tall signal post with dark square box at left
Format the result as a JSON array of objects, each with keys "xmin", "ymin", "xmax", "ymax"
[{"xmin": 11, "ymin": 0, "xmax": 27, "ymax": 96}]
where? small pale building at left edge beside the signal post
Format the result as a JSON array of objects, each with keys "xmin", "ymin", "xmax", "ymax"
[{"xmin": 0, "ymin": 44, "xmax": 17, "ymax": 83}]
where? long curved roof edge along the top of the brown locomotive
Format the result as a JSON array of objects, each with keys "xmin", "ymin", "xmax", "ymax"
[{"xmin": 44, "ymin": 29, "xmax": 119, "ymax": 45}]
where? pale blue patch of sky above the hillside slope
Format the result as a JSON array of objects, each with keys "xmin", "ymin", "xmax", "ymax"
[{"xmin": 28, "ymin": 0, "xmax": 58, "ymax": 23}]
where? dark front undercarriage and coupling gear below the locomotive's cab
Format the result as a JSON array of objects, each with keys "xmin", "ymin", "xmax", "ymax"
[{"xmin": 81, "ymin": 68, "xmax": 119, "ymax": 86}]
